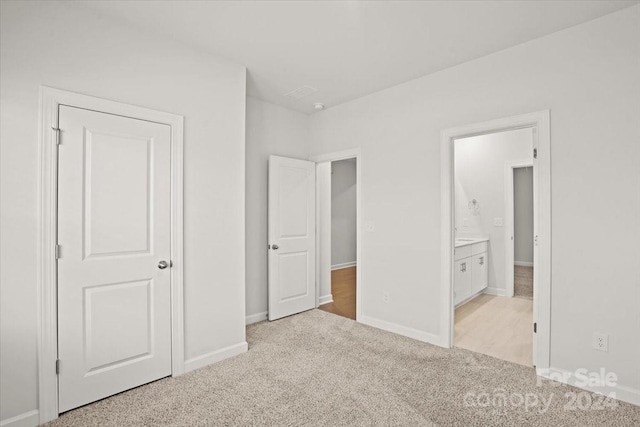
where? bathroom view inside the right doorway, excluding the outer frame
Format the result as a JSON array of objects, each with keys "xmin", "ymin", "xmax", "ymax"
[{"xmin": 453, "ymin": 128, "xmax": 534, "ymax": 366}]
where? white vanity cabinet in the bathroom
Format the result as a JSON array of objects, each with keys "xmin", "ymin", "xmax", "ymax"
[{"xmin": 453, "ymin": 239, "xmax": 489, "ymax": 306}]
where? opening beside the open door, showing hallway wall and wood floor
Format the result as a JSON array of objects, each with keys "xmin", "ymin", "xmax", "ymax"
[{"xmin": 319, "ymin": 158, "xmax": 358, "ymax": 320}]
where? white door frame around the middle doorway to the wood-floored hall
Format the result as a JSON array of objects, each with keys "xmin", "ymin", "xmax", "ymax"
[{"xmin": 309, "ymin": 148, "xmax": 363, "ymax": 321}]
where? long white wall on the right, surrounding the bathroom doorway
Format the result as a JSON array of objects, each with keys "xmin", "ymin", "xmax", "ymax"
[{"xmin": 311, "ymin": 6, "xmax": 640, "ymax": 401}]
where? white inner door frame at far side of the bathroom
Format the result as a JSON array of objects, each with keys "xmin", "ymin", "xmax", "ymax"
[{"xmin": 504, "ymin": 159, "xmax": 537, "ymax": 298}]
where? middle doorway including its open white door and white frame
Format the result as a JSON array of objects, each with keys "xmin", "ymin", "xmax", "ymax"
[{"xmin": 267, "ymin": 149, "xmax": 362, "ymax": 320}]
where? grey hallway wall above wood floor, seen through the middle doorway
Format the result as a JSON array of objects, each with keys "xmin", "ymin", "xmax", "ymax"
[{"xmin": 331, "ymin": 159, "xmax": 356, "ymax": 266}]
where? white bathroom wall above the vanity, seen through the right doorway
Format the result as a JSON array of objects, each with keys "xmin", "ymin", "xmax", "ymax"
[{"xmin": 454, "ymin": 128, "xmax": 533, "ymax": 294}]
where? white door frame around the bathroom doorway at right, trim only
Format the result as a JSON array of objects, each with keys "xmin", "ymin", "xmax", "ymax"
[{"xmin": 440, "ymin": 110, "xmax": 551, "ymax": 373}]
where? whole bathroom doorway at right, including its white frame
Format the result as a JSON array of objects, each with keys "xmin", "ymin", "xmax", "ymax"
[{"xmin": 441, "ymin": 110, "xmax": 551, "ymax": 375}]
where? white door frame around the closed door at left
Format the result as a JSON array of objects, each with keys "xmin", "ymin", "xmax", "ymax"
[{"xmin": 36, "ymin": 86, "xmax": 184, "ymax": 423}]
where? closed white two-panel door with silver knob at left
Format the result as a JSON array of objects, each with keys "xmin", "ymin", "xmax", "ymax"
[{"xmin": 58, "ymin": 106, "xmax": 171, "ymax": 412}]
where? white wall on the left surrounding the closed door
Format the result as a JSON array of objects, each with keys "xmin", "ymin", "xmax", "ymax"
[{"xmin": 0, "ymin": 2, "xmax": 246, "ymax": 420}]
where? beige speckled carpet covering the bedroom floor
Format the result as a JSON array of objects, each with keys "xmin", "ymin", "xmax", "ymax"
[{"xmin": 52, "ymin": 310, "xmax": 640, "ymax": 427}]
